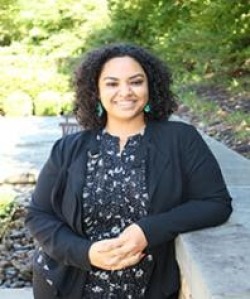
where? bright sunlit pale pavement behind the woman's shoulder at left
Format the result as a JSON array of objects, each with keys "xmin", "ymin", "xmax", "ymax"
[{"xmin": 0, "ymin": 117, "xmax": 62, "ymax": 180}]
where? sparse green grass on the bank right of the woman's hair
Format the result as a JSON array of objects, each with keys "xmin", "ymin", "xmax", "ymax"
[{"xmin": 176, "ymin": 77, "xmax": 250, "ymax": 158}]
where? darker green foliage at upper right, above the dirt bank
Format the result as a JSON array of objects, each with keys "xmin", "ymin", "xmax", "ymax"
[{"xmin": 102, "ymin": 0, "xmax": 250, "ymax": 75}]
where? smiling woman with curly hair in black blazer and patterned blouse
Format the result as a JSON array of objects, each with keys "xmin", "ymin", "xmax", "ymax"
[{"xmin": 26, "ymin": 44, "xmax": 231, "ymax": 299}]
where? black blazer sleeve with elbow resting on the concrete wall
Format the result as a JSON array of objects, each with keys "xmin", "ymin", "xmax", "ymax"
[{"xmin": 137, "ymin": 126, "xmax": 232, "ymax": 248}]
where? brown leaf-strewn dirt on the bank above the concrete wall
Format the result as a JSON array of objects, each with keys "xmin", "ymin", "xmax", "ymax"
[{"xmin": 177, "ymin": 84, "xmax": 250, "ymax": 159}]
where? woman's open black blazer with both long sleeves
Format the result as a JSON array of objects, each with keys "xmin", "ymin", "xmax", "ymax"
[{"xmin": 26, "ymin": 121, "xmax": 232, "ymax": 299}]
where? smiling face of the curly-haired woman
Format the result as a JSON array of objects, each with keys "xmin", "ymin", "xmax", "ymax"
[{"xmin": 98, "ymin": 56, "xmax": 149, "ymax": 125}]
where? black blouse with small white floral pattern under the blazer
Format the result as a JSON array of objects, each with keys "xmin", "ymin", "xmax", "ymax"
[{"xmin": 83, "ymin": 132, "xmax": 153, "ymax": 299}]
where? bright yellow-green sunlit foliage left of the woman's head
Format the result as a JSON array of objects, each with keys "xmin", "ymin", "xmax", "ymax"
[{"xmin": 0, "ymin": 0, "xmax": 109, "ymax": 115}]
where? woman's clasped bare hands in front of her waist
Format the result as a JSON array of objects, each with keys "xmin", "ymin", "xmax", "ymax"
[{"xmin": 89, "ymin": 224, "xmax": 148, "ymax": 270}]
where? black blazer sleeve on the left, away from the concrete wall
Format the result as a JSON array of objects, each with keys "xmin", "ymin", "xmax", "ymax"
[{"xmin": 25, "ymin": 139, "xmax": 91, "ymax": 270}]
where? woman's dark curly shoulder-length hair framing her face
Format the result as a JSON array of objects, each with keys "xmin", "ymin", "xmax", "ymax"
[{"xmin": 74, "ymin": 44, "xmax": 177, "ymax": 129}]
